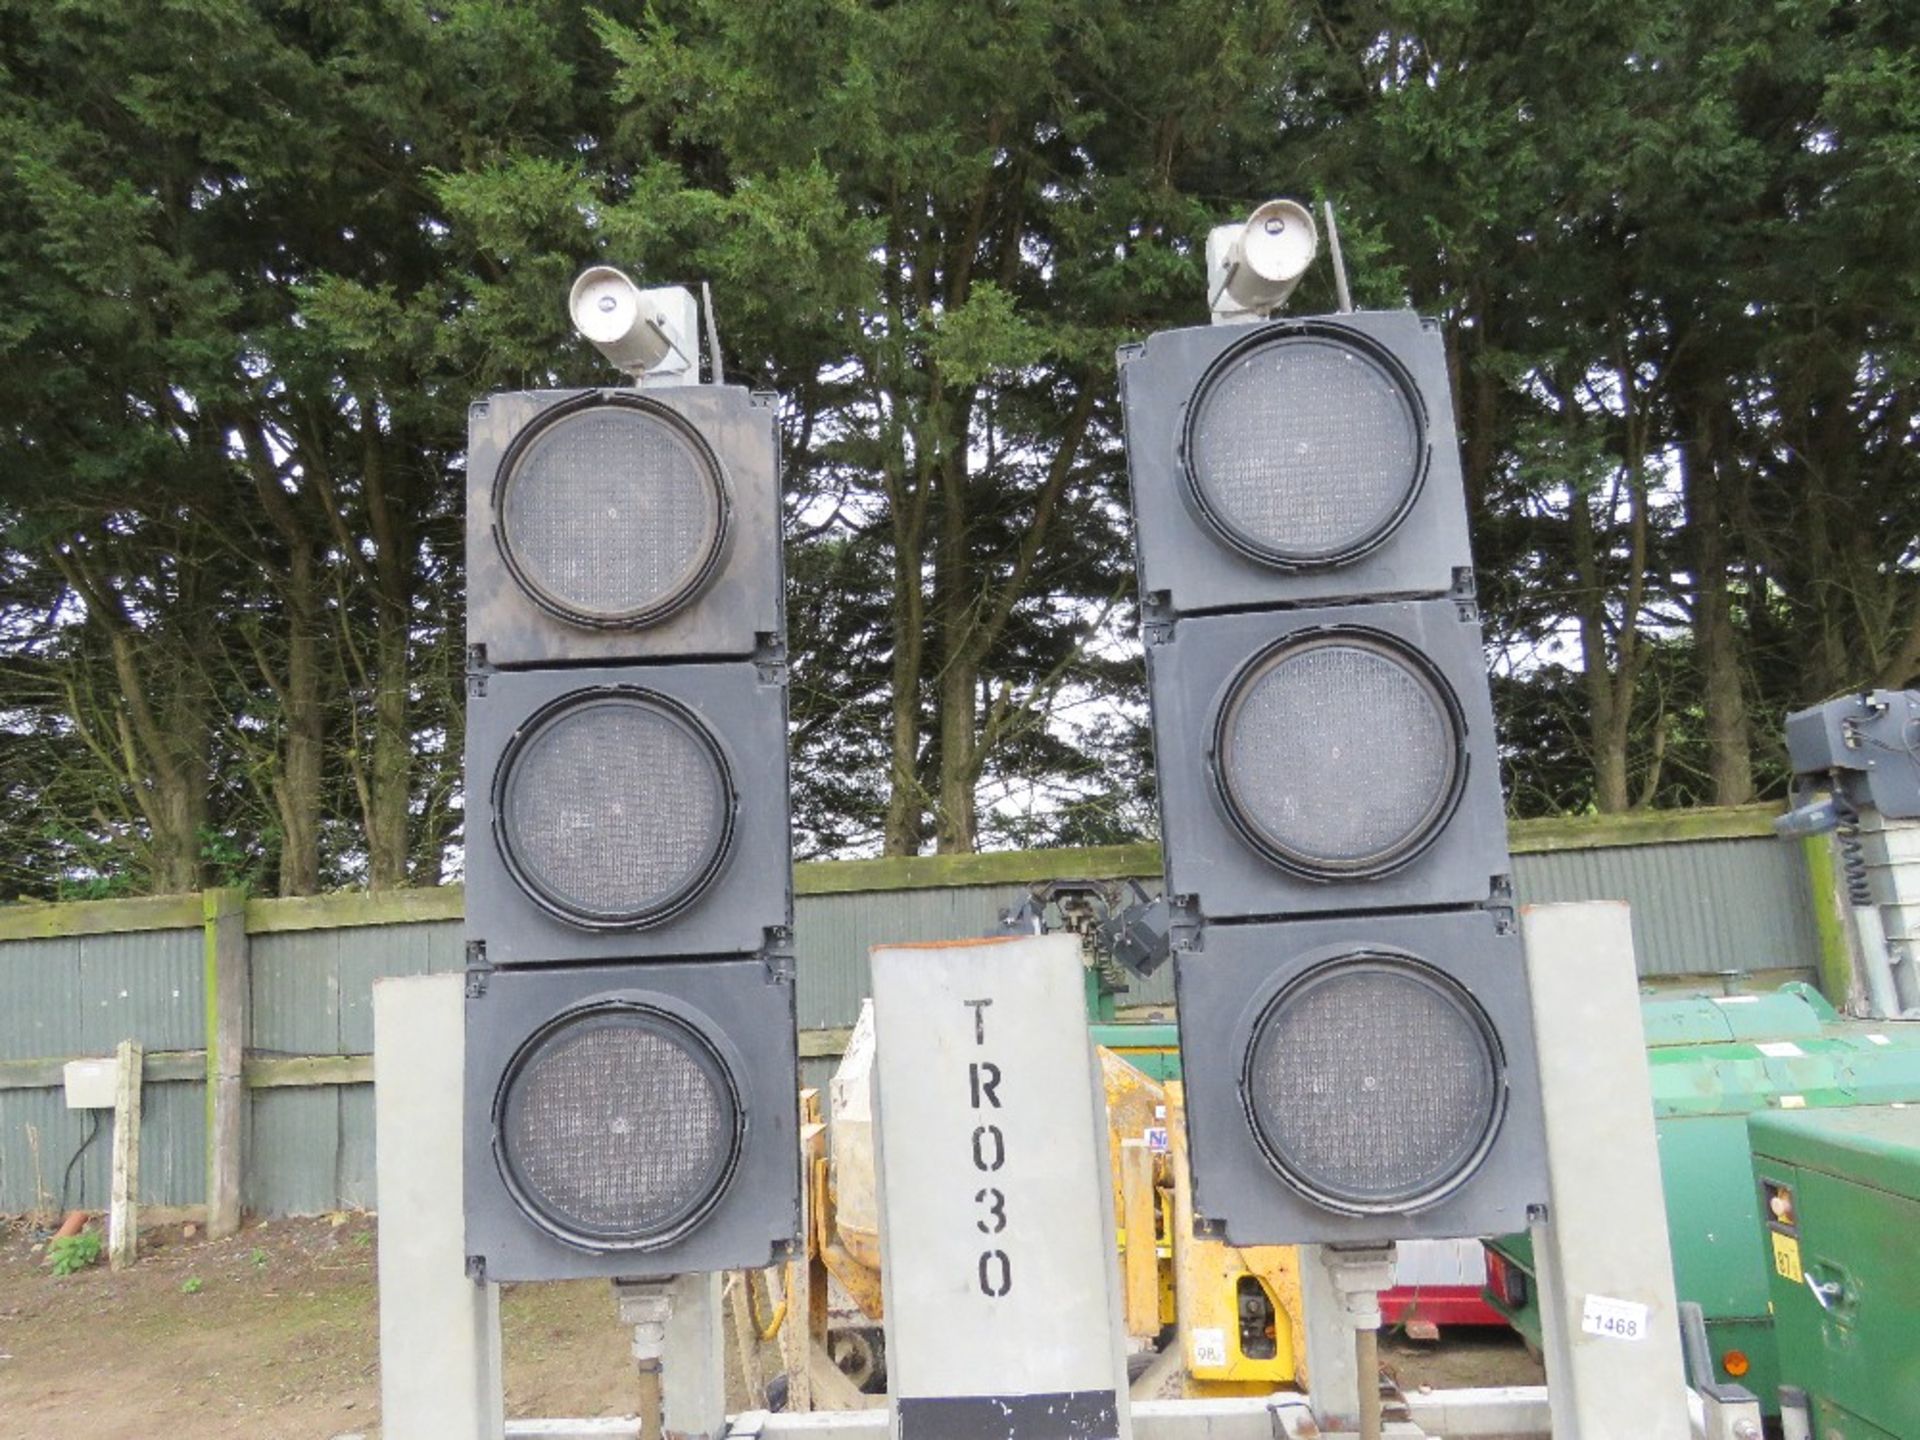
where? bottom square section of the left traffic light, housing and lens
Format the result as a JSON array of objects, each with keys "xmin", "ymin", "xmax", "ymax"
[{"xmin": 465, "ymin": 956, "xmax": 799, "ymax": 1281}]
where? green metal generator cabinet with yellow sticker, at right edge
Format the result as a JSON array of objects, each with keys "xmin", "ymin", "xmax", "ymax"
[{"xmin": 1749, "ymin": 1106, "xmax": 1920, "ymax": 1440}]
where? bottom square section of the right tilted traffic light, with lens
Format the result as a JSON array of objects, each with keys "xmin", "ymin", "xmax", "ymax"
[{"xmin": 1177, "ymin": 910, "xmax": 1544, "ymax": 1244}]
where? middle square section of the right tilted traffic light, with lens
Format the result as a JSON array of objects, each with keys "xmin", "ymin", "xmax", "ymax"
[{"xmin": 1146, "ymin": 599, "xmax": 1507, "ymax": 920}]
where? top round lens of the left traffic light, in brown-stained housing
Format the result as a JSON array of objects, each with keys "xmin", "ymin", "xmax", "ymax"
[{"xmin": 495, "ymin": 403, "xmax": 726, "ymax": 626}]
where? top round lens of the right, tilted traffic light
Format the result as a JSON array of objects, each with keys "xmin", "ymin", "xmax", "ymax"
[{"xmin": 1187, "ymin": 334, "xmax": 1425, "ymax": 566}]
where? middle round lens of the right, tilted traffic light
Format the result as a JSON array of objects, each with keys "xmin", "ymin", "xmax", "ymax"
[{"xmin": 1215, "ymin": 632, "xmax": 1465, "ymax": 877}]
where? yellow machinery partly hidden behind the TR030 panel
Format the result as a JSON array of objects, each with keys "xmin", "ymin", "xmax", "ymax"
[{"xmin": 806, "ymin": 1018, "xmax": 1306, "ymax": 1396}]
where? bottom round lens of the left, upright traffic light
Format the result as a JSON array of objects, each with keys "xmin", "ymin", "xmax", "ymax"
[{"xmin": 495, "ymin": 1006, "xmax": 741, "ymax": 1248}]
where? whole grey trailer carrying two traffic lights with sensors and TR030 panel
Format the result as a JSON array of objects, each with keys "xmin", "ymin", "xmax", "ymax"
[{"xmin": 376, "ymin": 247, "xmax": 1751, "ymax": 1440}]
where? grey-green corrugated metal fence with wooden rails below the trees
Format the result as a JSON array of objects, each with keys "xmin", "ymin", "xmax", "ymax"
[{"xmin": 0, "ymin": 806, "xmax": 1832, "ymax": 1215}]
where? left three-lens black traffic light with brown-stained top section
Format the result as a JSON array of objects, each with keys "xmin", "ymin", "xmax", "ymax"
[{"xmin": 465, "ymin": 374, "xmax": 801, "ymax": 1281}]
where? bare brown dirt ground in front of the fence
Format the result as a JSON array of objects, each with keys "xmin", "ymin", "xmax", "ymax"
[{"xmin": 0, "ymin": 1215, "xmax": 1540, "ymax": 1440}]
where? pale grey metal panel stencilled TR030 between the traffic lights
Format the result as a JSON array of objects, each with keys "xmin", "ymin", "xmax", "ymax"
[{"xmin": 874, "ymin": 935, "xmax": 1129, "ymax": 1440}]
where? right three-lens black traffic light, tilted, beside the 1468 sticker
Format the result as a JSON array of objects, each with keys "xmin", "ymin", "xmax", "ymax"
[{"xmin": 1119, "ymin": 311, "xmax": 1546, "ymax": 1244}]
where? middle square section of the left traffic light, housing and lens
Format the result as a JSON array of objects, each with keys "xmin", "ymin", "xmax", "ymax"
[{"xmin": 467, "ymin": 660, "xmax": 793, "ymax": 966}]
